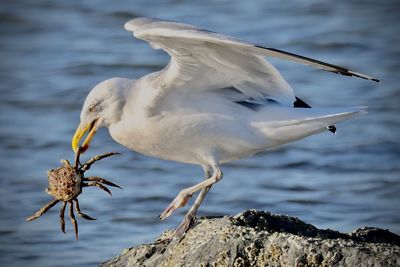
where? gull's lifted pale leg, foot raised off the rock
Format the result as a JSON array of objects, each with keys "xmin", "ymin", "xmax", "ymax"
[{"xmin": 159, "ymin": 166, "xmax": 222, "ymax": 220}]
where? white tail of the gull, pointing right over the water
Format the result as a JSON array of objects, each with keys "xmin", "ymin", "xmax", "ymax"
[{"xmin": 252, "ymin": 106, "xmax": 367, "ymax": 145}]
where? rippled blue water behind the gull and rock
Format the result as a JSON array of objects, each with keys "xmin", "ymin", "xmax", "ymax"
[{"xmin": 0, "ymin": 0, "xmax": 400, "ymax": 266}]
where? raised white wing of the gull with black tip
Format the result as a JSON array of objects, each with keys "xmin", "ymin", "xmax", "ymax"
[{"xmin": 125, "ymin": 18, "xmax": 378, "ymax": 105}]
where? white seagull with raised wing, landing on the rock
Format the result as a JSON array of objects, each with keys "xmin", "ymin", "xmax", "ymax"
[{"xmin": 72, "ymin": 18, "xmax": 379, "ymax": 238}]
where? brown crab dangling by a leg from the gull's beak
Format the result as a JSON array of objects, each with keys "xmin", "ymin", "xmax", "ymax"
[{"xmin": 27, "ymin": 147, "xmax": 122, "ymax": 239}]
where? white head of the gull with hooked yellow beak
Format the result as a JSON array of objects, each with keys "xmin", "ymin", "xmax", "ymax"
[{"xmin": 71, "ymin": 78, "xmax": 130, "ymax": 153}]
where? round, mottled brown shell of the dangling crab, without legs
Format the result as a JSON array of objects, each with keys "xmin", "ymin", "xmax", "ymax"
[{"xmin": 46, "ymin": 160, "xmax": 83, "ymax": 202}]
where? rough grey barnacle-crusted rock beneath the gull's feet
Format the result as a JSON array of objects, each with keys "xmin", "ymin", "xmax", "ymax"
[{"xmin": 101, "ymin": 210, "xmax": 400, "ymax": 267}]
